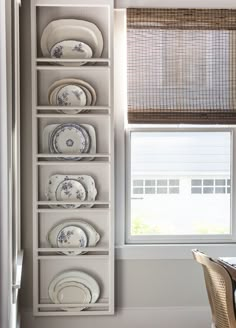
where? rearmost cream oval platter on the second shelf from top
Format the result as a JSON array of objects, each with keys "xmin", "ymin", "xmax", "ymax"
[{"xmin": 48, "ymin": 78, "xmax": 97, "ymax": 106}]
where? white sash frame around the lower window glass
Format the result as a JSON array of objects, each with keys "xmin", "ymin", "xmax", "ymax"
[{"xmin": 125, "ymin": 125, "xmax": 236, "ymax": 244}]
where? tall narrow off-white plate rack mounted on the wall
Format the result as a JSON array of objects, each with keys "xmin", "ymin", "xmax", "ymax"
[{"xmin": 31, "ymin": 0, "xmax": 114, "ymax": 316}]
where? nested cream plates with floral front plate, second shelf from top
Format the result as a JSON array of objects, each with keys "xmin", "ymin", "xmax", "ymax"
[{"xmin": 48, "ymin": 79, "xmax": 97, "ymax": 114}]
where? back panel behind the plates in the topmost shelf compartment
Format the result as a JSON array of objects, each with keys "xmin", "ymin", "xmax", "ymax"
[{"xmin": 36, "ymin": 3, "xmax": 111, "ymax": 58}]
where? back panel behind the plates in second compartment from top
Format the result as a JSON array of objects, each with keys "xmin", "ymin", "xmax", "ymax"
[{"xmin": 37, "ymin": 66, "xmax": 110, "ymax": 109}]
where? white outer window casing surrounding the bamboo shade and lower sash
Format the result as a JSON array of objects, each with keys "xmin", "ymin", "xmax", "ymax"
[{"xmin": 114, "ymin": 7, "xmax": 236, "ymax": 260}]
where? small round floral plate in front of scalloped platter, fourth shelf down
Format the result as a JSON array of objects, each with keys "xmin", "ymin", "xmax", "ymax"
[{"xmin": 55, "ymin": 179, "xmax": 86, "ymax": 208}]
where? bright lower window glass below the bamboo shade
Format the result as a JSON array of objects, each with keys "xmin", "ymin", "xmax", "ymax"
[{"xmin": 130, "ymin": 131, "xmax": 231, "ymax": 239}]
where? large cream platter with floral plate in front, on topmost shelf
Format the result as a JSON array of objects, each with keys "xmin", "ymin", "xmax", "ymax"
[{"xmin": 41, "ymin": 19, "xmax": 103, "ymax": 66}]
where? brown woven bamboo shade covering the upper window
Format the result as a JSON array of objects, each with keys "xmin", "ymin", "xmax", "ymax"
[{"xmin": 127, "ymin": 8, "xmax": 236, "ymax": 124}]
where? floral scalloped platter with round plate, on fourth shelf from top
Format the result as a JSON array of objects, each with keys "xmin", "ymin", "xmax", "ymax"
[{"xmin": 46, "ymin": 174, "xmax": 97, "ymax": 208}]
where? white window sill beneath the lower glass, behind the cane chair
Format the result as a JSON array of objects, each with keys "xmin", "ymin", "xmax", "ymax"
[{"xmin": 116, "ymin": 243, "xmax": 236, "ymax": 260}]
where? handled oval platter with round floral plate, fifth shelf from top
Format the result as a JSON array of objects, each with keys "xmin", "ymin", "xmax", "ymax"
[{"xmin": 47, "ymin": 220, "xmax": 100, "ymax": 255}]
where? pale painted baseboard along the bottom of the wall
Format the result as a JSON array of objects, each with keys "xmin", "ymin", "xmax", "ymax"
[{"xmin": 21, "ymin": 306, "xmax": 211, "ymax": 328}]
